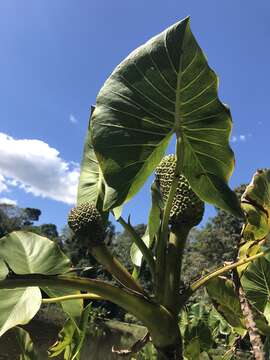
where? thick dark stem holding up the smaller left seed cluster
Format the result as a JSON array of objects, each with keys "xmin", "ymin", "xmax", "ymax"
[{"xmin": 89, "ymin": 244, "xmax": 144, "ymax": 294}]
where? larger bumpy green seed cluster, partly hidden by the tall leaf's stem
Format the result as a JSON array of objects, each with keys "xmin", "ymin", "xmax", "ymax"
[{"xmin": 156, "ymin": 155, "xmax": 204, "ymax": 227}]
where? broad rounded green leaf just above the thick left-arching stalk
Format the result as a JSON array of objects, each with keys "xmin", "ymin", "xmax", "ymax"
[{"xmin": 0, "ymin": 231, "xmax": 70, "ymax": 275}]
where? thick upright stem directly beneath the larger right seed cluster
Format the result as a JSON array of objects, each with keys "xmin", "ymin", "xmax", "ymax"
[{"xmin": 163, "ymin": 225, "xmax": 190, "ymax": 316}]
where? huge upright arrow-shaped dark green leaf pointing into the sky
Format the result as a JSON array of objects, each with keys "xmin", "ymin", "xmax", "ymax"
[{"xmin": 91, "ymin": 18, "xmax": 241, "ymax": 215}]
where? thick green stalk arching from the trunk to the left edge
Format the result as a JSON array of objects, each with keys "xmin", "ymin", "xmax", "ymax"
[{"xmin": 0, "ymin": 274, "xmax": 180, "ymax": 351}]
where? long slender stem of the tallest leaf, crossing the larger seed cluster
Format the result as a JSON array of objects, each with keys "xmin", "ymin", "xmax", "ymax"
[{"xmin": 155, "ymin": 136, "xmax": 181, "ymax": 300}]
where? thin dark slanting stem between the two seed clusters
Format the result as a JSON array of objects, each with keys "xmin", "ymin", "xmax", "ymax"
[{"xmin": 117, "ymin": 216, "xmax": 155, "ymax": 277}]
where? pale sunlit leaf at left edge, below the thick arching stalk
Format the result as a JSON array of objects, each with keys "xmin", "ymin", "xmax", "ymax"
[{"xmin": 0, "ymin": 287, "xmax": 41, "ymax": 336}]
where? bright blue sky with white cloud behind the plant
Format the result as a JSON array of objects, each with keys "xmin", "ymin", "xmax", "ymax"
[{"xmin": 0, "ymin": 0, "xmax": 270, "ymax": 232}]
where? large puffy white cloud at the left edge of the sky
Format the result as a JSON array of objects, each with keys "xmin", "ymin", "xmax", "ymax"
[{"xmin": 0, "ymin": 133, "xmax": 79, "ymax": 204}]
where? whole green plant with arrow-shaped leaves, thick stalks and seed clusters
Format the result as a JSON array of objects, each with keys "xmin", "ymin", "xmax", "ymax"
[{"xmin": 0, "ymin": 18, "xmax": 270, "ymax": 360}]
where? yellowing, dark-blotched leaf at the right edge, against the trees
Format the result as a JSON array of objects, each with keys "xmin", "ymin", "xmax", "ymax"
[{"xmin": 241, "ymin": 169, "xmax": 270, "ymax": 240}]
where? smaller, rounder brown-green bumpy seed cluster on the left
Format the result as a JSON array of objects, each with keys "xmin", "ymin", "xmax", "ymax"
[{"xmin": 68, "ymin": 202, "xmax": 105, "ymax": 246}]
